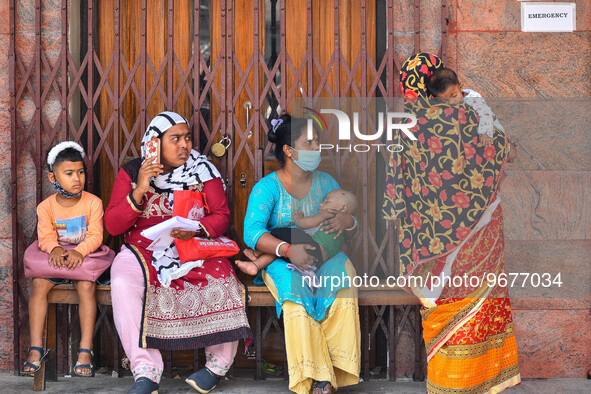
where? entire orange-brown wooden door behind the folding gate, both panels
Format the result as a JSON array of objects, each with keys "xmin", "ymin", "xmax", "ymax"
[{"xmin": 98, "ymin": 0, "xmax": 377, "ymax": 276}]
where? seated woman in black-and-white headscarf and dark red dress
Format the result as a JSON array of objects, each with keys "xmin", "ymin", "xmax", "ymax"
[{"xmin": 105, "ymin": 112, "xmax": 252, "ymax": 393}]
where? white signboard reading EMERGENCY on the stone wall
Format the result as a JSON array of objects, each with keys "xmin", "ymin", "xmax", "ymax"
[{"xmin": 521, "ymin": 3, "xmax": 577, "ymax": 32}]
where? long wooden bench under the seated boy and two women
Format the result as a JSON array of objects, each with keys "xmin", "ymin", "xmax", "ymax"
[{"xmin": 34, "ymin": 284, "xmax": 421, "ymax": 391}]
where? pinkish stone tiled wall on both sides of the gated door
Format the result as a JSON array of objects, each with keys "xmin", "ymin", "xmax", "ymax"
[{"xmin": 0, "ymin": 0, "xmax": 591, "ymax": 378}]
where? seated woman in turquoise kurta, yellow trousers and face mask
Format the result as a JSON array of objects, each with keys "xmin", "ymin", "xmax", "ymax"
[{"xmin": 244, "ymin": 115, "xmax": 360, "ymax": 393}]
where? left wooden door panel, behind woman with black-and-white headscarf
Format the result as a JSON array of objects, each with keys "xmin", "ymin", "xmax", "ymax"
[{"xmin": 95, "ymin": 0, "xmax": 215, "ymax": 212}]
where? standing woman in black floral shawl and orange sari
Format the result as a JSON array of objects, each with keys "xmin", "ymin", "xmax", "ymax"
[{"xmin": 383, "ymin": 53, "xmax": 521, "ymax": 393}]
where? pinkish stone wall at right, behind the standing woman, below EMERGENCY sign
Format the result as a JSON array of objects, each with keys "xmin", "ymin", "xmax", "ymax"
[{"xmin": 448, "ymin": 0, "xmax": 591, "ymax": 378}]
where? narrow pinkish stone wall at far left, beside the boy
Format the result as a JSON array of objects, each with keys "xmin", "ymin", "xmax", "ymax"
[{"xmin": 0, "ymin": 0, "xmax": 61, "ymax": 371}]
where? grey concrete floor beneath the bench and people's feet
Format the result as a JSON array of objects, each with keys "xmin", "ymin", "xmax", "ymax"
[{"xmin": 0, "ymin": 374, "xmax": 591, "ymax": 394}]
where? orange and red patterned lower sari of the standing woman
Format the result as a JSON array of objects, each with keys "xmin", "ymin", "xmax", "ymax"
[{"xmin": 412, "ymin": 206, "xmax": 520, "ymax": 393}]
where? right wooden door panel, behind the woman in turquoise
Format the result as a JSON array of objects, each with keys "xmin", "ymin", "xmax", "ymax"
[{"xmin": 231, "ymin": 0, "xmax": 377, "ymax": 269}]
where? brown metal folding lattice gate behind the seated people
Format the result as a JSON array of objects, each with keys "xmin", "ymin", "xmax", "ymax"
[{"xmin": 9, "ymin": 0, "xmax": 447, "ymax": 378}]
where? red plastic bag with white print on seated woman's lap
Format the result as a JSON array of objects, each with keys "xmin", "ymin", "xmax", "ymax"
[{"xmin": 172, "ymin": 190, "xmax": 240, "ymax": 263}]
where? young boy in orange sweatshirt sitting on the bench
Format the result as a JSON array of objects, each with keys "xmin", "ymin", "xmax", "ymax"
[{"xmin": 23, "ymin": 141, "xmax": 103, "ymax": 376}]
